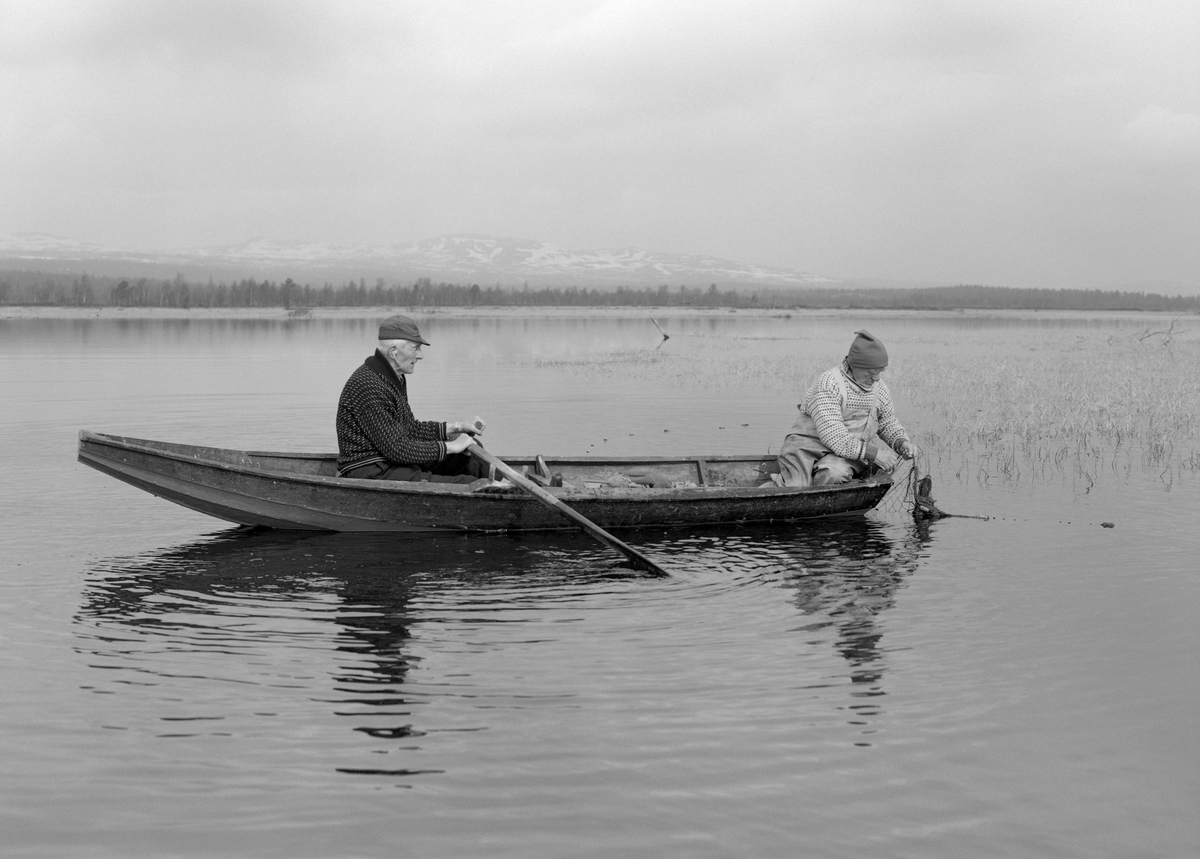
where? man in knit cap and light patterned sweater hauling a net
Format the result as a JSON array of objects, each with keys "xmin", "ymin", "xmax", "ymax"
[{"xmin": 772, "ymin": 331, "xmax": 917, "ymax": 486}]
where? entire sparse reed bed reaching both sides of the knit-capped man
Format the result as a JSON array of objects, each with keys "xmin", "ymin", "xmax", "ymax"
[{"xmin": 540, "ymin": 322, "xmax": 1200, "ymax": 492}]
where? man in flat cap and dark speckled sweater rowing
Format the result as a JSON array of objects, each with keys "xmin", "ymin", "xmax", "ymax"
[{"xmin": 337, "ymin": 316, "xmax": 488, "ymax": 483}]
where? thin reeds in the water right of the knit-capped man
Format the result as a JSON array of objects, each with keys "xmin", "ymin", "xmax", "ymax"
[{"xmin": 892, "ymin": 332, "xmax": 1200, "ymax": 491}]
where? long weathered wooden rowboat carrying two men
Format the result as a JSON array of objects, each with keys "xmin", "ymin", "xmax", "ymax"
[{"xmin": 79, "ymin": 430, "xmax": 892, "ymax": 531}]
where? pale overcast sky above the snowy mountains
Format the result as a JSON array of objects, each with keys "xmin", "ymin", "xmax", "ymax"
[{"xmin": 0, "ymin": 0, "xmax": 1200, "ymax": 293}]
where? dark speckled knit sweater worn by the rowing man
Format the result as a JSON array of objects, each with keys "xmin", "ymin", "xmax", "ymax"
[{"xmin": 337, "ymin": 349, "xmax": 446, "ymax": 474}]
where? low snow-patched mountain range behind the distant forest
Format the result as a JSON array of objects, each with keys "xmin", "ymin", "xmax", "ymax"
[{"xmin": 0, "ymin": 235, "xmax": 838, "ymax": 287}]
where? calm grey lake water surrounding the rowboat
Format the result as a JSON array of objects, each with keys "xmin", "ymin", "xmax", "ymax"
[{"xmin": 0, "ymin": 313, "xmax": 1200, "ymax": 859}]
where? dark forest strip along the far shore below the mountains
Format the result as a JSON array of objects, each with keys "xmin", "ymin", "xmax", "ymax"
[{"xmin": 0, "ymin": 271, "xmax": 1200, "ymax": 313}]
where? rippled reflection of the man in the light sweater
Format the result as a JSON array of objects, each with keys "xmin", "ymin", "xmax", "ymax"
[{"xmin": 768, "ymin": 518, "xmax": 929, "ymax": 733}]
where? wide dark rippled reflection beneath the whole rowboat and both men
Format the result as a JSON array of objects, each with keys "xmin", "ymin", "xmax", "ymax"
[{"xmin": 76, "ymin": 517, "xmax": 922, "ymax": 779}]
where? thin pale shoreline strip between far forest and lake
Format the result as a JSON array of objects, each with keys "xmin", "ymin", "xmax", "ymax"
[{"xmin": 0, "ymin": 305, "xmax": 1193, "ymax": 322}]
